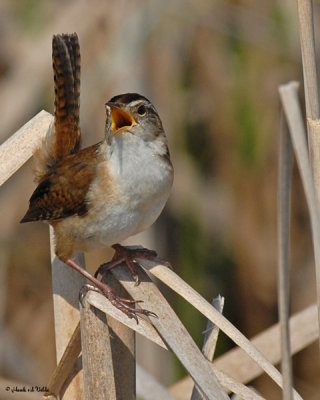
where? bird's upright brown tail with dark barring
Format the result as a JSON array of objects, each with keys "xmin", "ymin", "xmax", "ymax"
[{"xmin": 50, "ymin": 33, "xmax": 81, "ymax": 164}]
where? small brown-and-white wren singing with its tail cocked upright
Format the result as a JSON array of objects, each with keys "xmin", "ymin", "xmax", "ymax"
[{"xmin": 20, "ymin": 33, "xmax": 174, "ymax": 320}]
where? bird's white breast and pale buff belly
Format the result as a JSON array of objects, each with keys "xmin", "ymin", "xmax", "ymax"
[{"xmin": 73, "ymin": 133, "xmax": 173, "ymax": 249}]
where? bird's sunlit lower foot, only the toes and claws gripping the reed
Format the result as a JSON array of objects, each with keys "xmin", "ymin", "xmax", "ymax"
[{"xmin": 79, "ymin": 282, "xmax": 158, "ymax": 324}]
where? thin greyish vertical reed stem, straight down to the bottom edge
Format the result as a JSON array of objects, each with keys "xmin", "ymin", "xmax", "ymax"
[{"xmin": 277, "ymin": 115, "xmax": 293, "ymax": 400}]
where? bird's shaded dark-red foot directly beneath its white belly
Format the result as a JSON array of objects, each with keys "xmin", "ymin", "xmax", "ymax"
[{"xmin": 94, "ymin": 243, "xmax": 171, "ymax": 285}]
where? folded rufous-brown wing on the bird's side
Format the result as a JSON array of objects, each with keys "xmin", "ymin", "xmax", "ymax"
[{"xmin": 20, "ymin": 143, "xmax": 99, "ymax": 222}]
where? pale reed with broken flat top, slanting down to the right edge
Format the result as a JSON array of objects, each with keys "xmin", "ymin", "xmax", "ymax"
[{"xmin": 279, "ymin": 82, "xmax": 320, "ymax": 348}]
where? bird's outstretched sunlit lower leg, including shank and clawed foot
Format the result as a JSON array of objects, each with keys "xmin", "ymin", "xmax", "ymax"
[{"xmin": 66, "ymin": 259, "xmax": 156, "ymax": 323}]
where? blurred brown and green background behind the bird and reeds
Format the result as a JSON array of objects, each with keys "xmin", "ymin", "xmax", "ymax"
[{"xmin": 0, "ymin": 0, "xmax": 320, "ymax": 399}]
